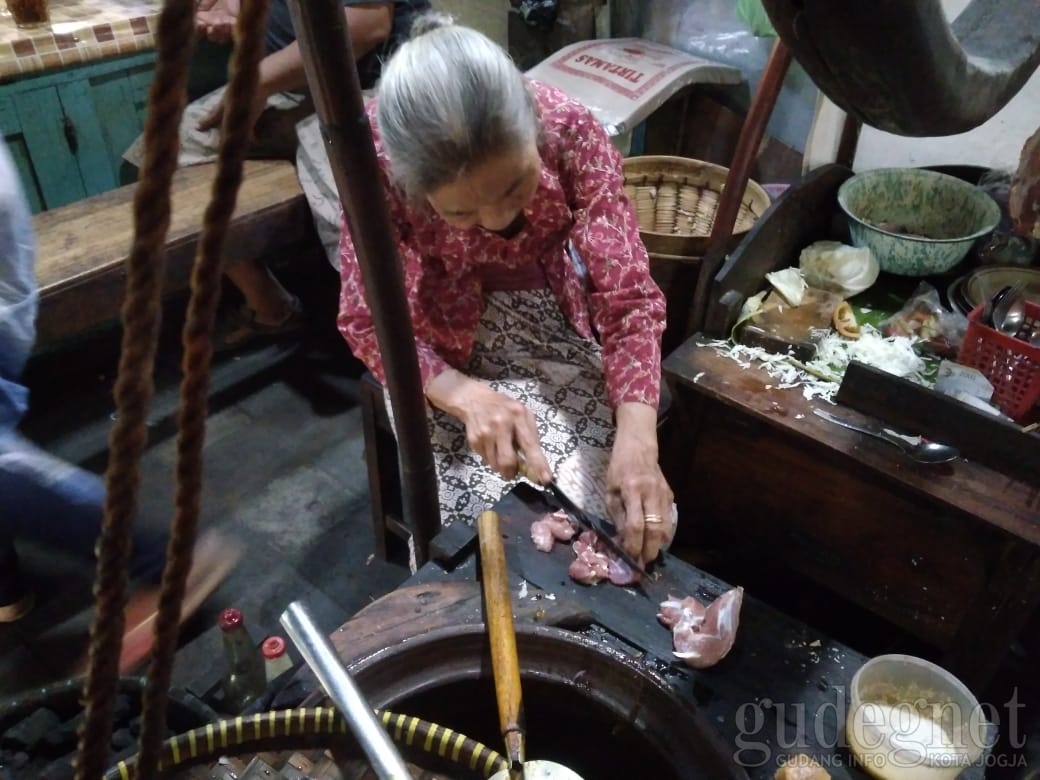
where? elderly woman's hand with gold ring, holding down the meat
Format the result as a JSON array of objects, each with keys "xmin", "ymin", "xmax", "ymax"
[{"xmin": 606, "ymin": 404, "xmax": 675, "ymax": 564}]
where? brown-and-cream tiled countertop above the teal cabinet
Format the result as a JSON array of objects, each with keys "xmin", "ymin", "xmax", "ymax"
[{"xmin": 0, "ymin": 0, "xmax": 161, "ymax": 83}]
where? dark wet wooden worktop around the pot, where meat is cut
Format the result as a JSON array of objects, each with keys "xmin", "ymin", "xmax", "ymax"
[{"xmin": 318, "ymin": 486, "xmax": 998, "ymax": 780}]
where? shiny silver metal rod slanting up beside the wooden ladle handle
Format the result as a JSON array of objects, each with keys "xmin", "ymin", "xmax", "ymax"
[{"xmin": 279, "ymin": 601, "xmax": 412, "ymax": 780}]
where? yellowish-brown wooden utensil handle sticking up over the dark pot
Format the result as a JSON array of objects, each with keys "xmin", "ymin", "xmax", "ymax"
[{"xmin": 476, "ymin": 510, "xmax": 524, "ymax": 766}]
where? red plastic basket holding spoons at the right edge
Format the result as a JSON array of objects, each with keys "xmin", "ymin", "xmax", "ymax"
[{"xmin": 957, "ymin": 301, "xmax": 1040, "ymax": 421}]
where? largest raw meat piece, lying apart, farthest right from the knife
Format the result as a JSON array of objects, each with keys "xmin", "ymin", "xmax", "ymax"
[{"xmin": 657, "ymin": 588, "xmax": 744, "ymax": 669}]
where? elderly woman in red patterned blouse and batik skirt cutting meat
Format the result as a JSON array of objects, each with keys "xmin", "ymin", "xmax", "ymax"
[{"xmin": 339, "ymin": 15, "xmax": 675, "ymax": 562}]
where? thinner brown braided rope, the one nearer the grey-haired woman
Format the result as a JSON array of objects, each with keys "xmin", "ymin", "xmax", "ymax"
[{"xmin": 136, "ymin": 0, "xmax": 267, "ymax": 778}]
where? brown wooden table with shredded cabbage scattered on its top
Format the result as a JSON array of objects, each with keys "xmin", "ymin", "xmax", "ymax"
[{"xmin": 665, "ymin": 337, "xmax": 1040, "ymax": 693}]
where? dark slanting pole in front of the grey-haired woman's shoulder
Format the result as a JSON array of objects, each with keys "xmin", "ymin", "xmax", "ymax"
[{"xmin": 289, "ymin": 0, "xmax": 441, "ymax": 566}]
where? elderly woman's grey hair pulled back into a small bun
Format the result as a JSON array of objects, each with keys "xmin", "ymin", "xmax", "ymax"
[{"xmin": 375, "ymin": 14, "xmax": 539, "ymax": 199}]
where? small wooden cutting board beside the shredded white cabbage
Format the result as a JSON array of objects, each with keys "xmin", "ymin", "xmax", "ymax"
[{"xmin": 738, "ymin": 287, "xmax": 843, "ymax": 361}]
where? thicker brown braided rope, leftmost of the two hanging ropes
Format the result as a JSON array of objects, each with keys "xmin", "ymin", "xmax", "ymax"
[{"xmin": 76, "ymin": 0, "xmax": 194, "ymax": 780}]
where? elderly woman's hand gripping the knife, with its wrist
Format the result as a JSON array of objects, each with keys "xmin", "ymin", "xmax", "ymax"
[{"xmin": 426, "ymin": 369, "xmax": 552, "ymax": 484}]
